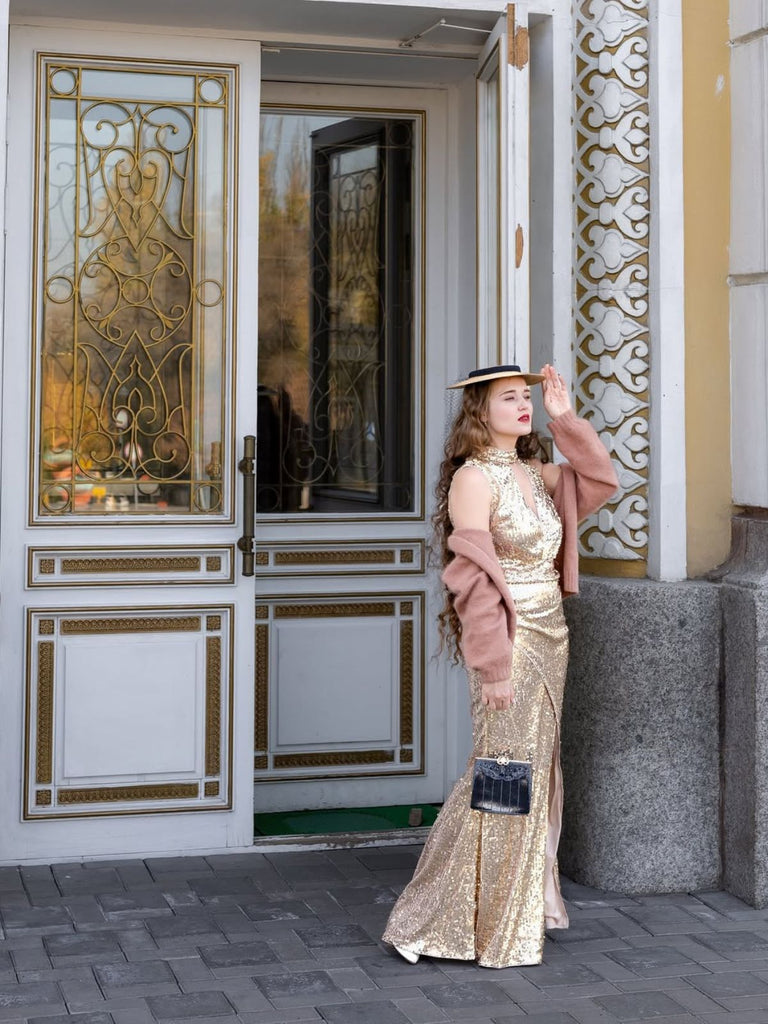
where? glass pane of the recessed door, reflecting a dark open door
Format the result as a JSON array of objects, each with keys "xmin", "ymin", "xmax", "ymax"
[{"xmin": 257, "ymin": 113, "xmax": 413, "ymax": 513}]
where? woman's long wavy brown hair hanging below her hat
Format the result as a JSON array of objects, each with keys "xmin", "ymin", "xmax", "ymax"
[{"xmin": 430, "ymin": 381, "xmax": 549, "ymax": 662}]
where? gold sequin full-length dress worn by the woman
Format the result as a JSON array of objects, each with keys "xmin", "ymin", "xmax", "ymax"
[{"xmin": 383, "ymin": 449, "xmax": 568, "ymax": 968}]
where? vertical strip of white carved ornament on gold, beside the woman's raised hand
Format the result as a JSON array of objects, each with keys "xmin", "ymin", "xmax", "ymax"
[{"xmin": 574, "ymin": 0, "xmax": 650, "ymax": 574}]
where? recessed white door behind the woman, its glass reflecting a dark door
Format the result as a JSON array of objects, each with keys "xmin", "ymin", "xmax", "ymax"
[{"xmin": 254, "ymin": 82, "xmax": 454, "ymax": 812}]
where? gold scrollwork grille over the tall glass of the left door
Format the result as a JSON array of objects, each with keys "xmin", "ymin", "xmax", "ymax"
[{"xmin": 35, "ymin": 56, "xmax": 233, "ymax": 517}]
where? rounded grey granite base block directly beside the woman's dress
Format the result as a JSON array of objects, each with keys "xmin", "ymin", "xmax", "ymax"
[{"xmin": 559, "ymin": 577, "xmax": 721, "ymax": 895}]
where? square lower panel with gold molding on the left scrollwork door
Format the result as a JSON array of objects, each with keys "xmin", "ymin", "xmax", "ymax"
[{"xmin": 24, "ymin": 605, "xmax": 234, "ymax": 820}]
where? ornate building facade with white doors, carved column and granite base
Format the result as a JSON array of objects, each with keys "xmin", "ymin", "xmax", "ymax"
[{"xmin": 0, "ymin": 0, "xmax": 757, "ymax": 902}]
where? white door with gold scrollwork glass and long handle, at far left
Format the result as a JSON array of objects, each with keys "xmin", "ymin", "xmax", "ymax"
[{"xmin": 0, "ymin": 29, "xmax": 260, "ymax": 862}]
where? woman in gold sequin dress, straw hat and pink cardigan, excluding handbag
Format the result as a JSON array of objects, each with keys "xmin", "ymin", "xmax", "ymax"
[{"xmin": 383, "ymin": 365, "xmax": 617, "ymax": 968}]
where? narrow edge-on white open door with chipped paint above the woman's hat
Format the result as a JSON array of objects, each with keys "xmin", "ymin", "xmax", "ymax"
[{"xmin": 476, "ymin": 2, "xmax": 529, "ymax": 367}]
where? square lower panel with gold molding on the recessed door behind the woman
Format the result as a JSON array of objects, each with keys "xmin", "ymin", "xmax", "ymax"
[{"xmin": 254, "ymin": 591, "xmax": 426, "ymax": 783}]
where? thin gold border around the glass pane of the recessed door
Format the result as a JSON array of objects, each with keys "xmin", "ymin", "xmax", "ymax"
[{"xmin": 256, "ymin": 101, "xmax": 428, "ymax": 524}]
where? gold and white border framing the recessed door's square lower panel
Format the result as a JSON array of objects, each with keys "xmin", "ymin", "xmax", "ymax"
[{"xmin": 254, "ymin": 591, "xmax": 426, "ymax": 783}]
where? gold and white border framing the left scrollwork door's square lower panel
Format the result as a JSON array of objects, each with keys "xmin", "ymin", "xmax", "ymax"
[{"xmin": 23, "ymin": 604, "xmax": 234, "ymax": 820}]
